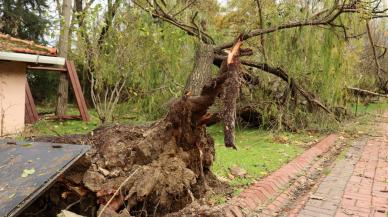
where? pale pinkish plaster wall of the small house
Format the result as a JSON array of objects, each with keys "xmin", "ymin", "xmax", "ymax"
[{"xmin": 0, "ymin": 61, "xmax": 27, "ymax": 136}]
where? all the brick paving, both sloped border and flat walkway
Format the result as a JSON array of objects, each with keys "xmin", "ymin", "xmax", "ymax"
[{"xmin": 224, "ymin": 118, "xmax": 388, "ymax": 217}]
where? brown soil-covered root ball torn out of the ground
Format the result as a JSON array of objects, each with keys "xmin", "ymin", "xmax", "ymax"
[{"xmin": 25, "ymin": 118, "xmax": 220, "ymax": 216}]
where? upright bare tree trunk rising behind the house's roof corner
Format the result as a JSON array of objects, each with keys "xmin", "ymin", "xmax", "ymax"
[{"xmin": 56, "ymin": 0, "xmax": 72, "ymax": 116}]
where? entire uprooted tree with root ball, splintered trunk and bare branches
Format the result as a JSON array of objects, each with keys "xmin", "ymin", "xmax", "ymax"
[{"xmin": 23, "ymin": 0, "xmax": 386, "ymax": 216}]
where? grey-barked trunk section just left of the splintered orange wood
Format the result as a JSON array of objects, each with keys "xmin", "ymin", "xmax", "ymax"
[{"xmin": 185, "ymin": 42, "xmax": 214, "ymax": 95}]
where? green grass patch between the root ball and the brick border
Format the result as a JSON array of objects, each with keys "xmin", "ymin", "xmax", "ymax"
[{"xmin": 209, "ymin": 126, "xmax": 318, "ymax": 188}]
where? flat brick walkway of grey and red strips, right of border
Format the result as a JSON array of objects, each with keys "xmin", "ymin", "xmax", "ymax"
[{"xmin": 297, "ymin": 123, "xmax": 388, "ymax": 217}]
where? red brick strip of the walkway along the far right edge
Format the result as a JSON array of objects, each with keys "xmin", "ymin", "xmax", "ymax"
[{"xmin": 335, "ymin": 136, "xmax": 388, "ymax": 217}]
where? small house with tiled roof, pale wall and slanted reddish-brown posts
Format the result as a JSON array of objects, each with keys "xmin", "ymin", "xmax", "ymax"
[{"xmin": 0, "ymin": 33, "xmax": 89, "ymax": 136}]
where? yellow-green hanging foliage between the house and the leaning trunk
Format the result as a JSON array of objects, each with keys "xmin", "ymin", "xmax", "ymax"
[{"xmin": 73, "ymin": 3, "xmax": 197, "ymax": 120}]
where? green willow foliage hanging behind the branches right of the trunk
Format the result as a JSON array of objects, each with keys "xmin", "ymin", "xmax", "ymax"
[{"xmin": 218, "ymin": 0, "xmax": 384, "ymax": 130}]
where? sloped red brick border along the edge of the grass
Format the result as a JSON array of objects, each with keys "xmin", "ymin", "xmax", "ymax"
[{"xmin": 223, "ymin": 134, "xmax": 338, "ymax": 217}]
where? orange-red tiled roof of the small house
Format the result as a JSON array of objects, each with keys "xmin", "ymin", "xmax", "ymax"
[{"xmin": 0, "ymin": 33, "xmax": 57, "ymax": 56}]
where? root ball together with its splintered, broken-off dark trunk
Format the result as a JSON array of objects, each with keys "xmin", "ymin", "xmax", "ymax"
[{"xmin": 25, "ymin": 38, "xmax": 246, "ymax": 216}]
